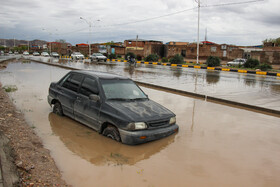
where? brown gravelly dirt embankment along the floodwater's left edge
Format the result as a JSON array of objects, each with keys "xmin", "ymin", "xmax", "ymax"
[{"xmin": 0, "ymin": 62, "xmax": 68, "ymax": 186}]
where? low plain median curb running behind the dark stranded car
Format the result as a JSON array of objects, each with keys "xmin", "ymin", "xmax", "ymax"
[{"xmin": 25, "ymin": 60, "xmax": 280, "ymax": 117}]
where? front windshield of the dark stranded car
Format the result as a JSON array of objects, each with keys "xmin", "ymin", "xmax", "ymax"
[{"xmin": 101, "ymin": 79, "xmax": 147, "ymax": 100}]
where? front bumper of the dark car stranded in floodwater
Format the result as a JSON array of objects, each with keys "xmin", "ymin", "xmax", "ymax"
[{"xmin": 119, "ymin": 124, "xmax": 179, "ymax": 145}]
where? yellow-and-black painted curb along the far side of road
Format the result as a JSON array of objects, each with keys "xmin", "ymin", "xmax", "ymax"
[{"xmin": 107, "ymin": 59, "xmax": 280, "ymax": 77}]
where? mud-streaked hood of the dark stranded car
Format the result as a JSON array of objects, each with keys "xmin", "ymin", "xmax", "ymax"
[{"xmin": 106, "ymin": 99, "xmax": 175, "ymax": 122}]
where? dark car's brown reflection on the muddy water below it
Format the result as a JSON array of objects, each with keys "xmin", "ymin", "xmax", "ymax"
[{"xmin": 49, "ymin": 113, "xmax": 175, "ymax": 165}]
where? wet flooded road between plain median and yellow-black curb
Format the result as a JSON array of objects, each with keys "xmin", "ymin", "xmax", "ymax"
[{"xmin": 27, "ymin": 57, "xmax": 280, "ymax": 110}]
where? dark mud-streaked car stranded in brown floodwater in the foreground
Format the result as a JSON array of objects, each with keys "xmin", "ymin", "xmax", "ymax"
[{"xmin": 48, "ymin": 71, "xmax": 179, "ymax": 145}]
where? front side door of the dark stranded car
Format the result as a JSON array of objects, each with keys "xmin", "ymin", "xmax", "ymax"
[{"xmin": 74, "ymin": 76, "xmax": 101, "ymax": 130}]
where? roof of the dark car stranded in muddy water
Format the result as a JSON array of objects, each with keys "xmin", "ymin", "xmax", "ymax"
[{"xmin": 71, "ymin": 70, "xmax": 129, "ymax": 79}]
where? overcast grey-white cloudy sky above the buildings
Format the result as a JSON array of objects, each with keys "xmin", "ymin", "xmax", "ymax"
[{"xmin": 0, "ymin": 0, "xmax": 280, "ymax": 45}]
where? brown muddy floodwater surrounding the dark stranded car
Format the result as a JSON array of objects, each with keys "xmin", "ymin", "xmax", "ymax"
[{"xmin": 0, "ymin": 62, "xmax": 280, "ymax": 187}]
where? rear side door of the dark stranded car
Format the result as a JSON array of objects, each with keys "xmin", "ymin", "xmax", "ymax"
[{"xmin": 58, "ymin": 73, "xmax": 83, "ymax": 118}]
